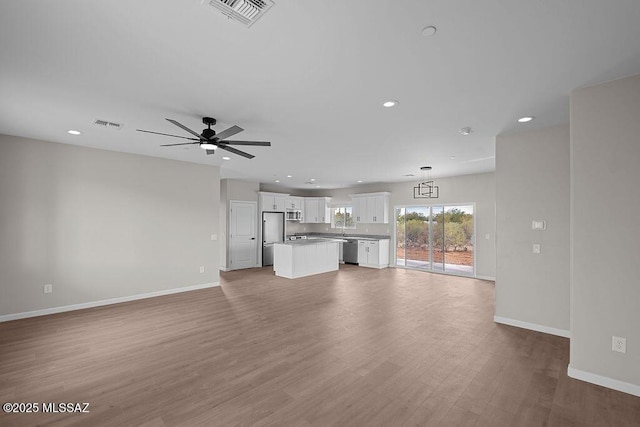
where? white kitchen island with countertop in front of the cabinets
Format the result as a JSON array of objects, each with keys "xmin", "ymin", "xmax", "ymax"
[{"xmin": 273, "ymin": 238, "xmax": 344, "ymax": 279}]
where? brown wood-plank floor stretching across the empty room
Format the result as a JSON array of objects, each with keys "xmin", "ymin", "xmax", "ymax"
[{"xmin": 0, "ymin": 265, "xmax": 640, "ymax": 427}]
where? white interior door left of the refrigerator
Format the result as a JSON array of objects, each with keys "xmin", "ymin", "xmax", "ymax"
[{"xmin": 229, "ymin": 201, "xmax": 258, "ymax": 270}]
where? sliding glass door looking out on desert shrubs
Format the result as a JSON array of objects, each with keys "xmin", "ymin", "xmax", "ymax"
[{"xmin": 396, "ymin": 205, "xmax": 475, "ymax": 276}]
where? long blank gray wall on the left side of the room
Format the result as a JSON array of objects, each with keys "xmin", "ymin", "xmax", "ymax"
[{"xmin": 0, "ymin": 135, "xmax": 220, "ymax": 315}]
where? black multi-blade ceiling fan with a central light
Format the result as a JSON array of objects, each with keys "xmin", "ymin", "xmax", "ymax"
[{"xmin": 136, "ymin": 117, "xmax": 271, "ymax": 159}]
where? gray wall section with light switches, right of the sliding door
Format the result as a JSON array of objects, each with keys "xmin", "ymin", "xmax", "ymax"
[{"xmin": 496, "ymin": 125, "xmax": 570, "ymax": 336}]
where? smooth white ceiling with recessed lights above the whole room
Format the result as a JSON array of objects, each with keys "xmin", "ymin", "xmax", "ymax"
[{"xmin": 0, "ymin": 0, "xmax": 640, "ymax": 188}]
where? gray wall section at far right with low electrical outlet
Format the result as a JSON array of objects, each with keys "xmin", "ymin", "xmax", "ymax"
[{"xmin": 570, "ymin": 76, "xmax": 640, "ymax": 393}]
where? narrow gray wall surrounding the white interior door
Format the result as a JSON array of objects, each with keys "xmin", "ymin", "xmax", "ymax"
[{"xmin": 219, "ymin": 179, "xmax": 260, "ymax": 271}]
